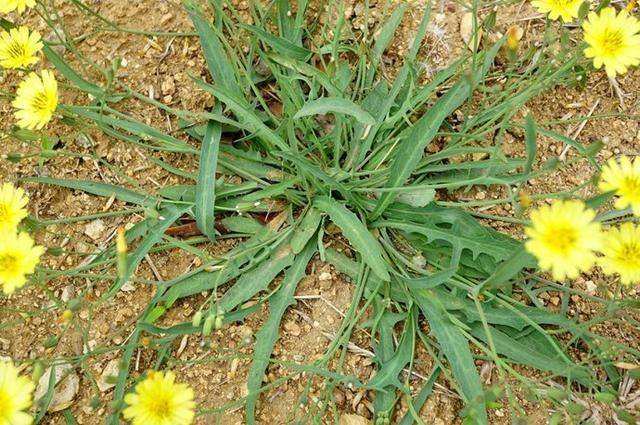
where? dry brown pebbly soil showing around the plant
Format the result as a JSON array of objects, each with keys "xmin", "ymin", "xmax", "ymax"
[{"xmin": 0, "ymin": 0, "xmax": 640, "ymax": 425}]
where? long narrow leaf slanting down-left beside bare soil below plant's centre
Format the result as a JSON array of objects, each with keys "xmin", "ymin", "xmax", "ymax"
[{"xmin": 246, "ymin": 242, "xmax": 316, "ymax": 425}]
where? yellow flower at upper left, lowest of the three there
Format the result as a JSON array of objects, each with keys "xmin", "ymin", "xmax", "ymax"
[{"xmin": 12, "ymin": 70, "xmax": 58, "ymax": 130}]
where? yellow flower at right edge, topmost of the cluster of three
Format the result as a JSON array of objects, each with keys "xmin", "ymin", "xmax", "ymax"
[{"xmin": 598, "ymin": 155, "xmax": 640, "ymax": 216}]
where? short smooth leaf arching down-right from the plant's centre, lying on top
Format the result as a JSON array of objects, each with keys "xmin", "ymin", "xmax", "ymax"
[{"xmin": 313, "ymin": 196, "xmax": 391, "ymax": 281}]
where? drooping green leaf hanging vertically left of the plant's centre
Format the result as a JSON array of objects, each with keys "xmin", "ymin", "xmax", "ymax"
[{"xmin": 194, "ymin": 117, "xmax": 222, "ymax": 240}]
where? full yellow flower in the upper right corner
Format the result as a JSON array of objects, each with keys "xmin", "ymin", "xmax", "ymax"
[{"xmin": 582, "ymin": 7, "xmax": 640, "ymax": 77}]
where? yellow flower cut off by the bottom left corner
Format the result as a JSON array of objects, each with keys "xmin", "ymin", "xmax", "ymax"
[{"xmin": 0, "ymin": 361, "xmax": 34, "ymax": 425}]
